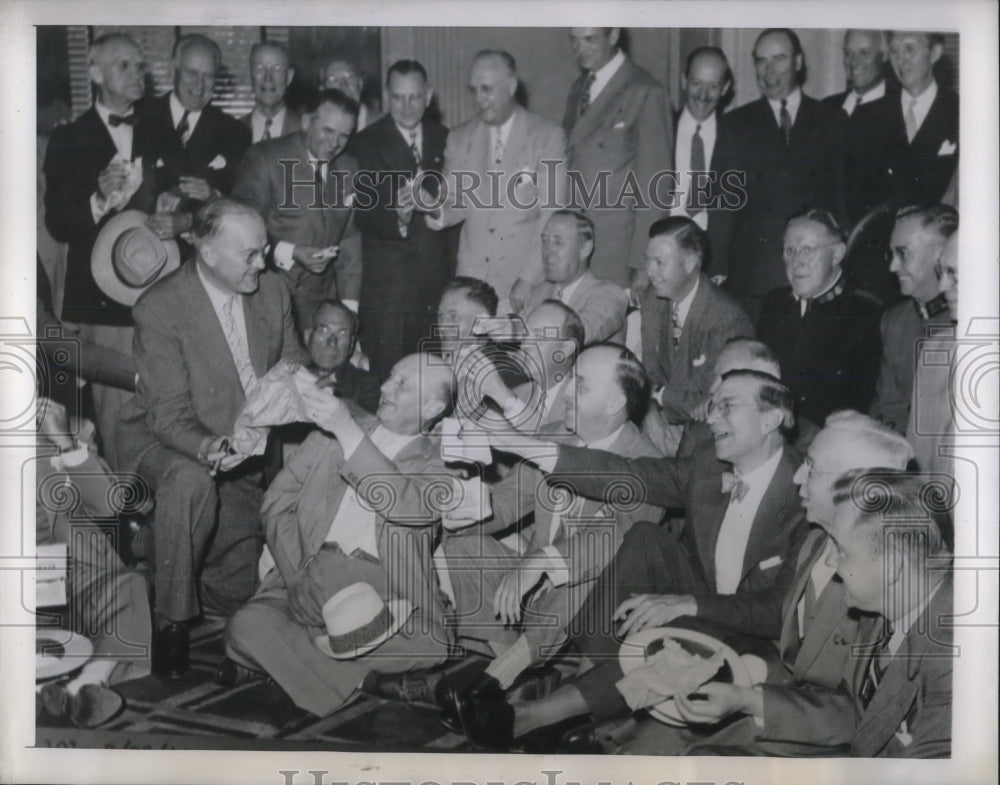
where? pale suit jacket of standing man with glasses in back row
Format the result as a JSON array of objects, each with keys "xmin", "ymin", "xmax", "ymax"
[{"xmin": 443, "ymin": 107, "xmax": 566, "ymax": 300}]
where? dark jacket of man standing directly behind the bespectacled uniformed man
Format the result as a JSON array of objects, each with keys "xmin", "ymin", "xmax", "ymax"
[{"xmin": 708, "ymin": 94, "xmax": 847, "ymax": 297}]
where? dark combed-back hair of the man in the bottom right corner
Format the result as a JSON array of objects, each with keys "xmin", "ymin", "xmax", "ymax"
[{"xmin": 833, "ymin": 468, "xmax": 957, "ymax": 559}]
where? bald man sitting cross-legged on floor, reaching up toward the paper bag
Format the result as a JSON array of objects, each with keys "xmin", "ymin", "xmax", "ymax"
[{"xmin": 226, "ymin": 354, "xmax": 453, "ymax": 717}]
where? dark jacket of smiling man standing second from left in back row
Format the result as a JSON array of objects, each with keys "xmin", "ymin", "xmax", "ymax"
[{"xmin": 140, "ymin": 93, "xmax": 250, "ymax": 194}]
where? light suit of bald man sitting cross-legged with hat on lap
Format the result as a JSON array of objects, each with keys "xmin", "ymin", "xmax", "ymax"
[{"xmin": 226, "ymin": 418, "xmax": 450, "ymax": 716}]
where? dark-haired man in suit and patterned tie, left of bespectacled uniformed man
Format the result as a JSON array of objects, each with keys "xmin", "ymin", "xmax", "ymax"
[{"xmin": 639, "ymin": 216, "xmax": 753, "ymax": 455}]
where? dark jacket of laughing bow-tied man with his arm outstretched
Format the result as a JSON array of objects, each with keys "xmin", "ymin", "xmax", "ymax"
[{"xmin": 553, "ymin": 445, "xmax": 806, "ymax": 638}]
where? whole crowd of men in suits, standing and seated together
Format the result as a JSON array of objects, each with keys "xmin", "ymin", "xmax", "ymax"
[{"xmin": 38, "ymin": 28, "xmax": 958, "ymax": 757}]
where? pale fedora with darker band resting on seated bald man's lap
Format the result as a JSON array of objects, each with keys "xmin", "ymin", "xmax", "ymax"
[{"xmin": 315, "ymin": 582, "xmax": 413, "ymax": 660}]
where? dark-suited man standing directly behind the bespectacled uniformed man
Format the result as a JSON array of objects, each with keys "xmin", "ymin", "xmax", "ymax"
[{"xmin": 711, "ymin": 28, "xmax": 847, "ymax": 317}]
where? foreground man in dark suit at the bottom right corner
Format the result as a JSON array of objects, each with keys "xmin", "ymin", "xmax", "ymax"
[{"xmin": 676, "ymin": 470, "xmax": 957, "ymax": 758}]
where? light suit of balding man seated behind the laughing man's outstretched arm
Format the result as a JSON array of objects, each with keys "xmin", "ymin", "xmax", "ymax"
[{"xmin": 442, "ymin": 422, "xmax": 663, "ymax": 661}]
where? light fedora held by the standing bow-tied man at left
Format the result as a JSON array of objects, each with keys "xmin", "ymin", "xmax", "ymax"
[{"xmin": 90, "ymin": 210, "xmax": 181, "ymax": 305}]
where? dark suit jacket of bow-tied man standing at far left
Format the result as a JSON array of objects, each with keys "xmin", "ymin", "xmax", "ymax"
[{"xmin": 44, "ymin": 107, "xmax": 168, "ymax": 325}]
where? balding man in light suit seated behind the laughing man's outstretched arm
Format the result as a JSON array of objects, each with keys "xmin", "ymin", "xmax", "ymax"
[{"xmin": 366, "ymin": 344, "xmax": 662, "ymax": 702}]
